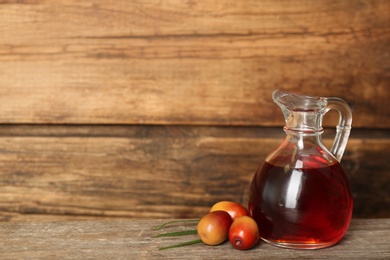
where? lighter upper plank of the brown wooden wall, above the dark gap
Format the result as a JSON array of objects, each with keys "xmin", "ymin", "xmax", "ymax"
[{"xmin": 0, "ymin": 0, "xmax": 390, "ymax": 128}]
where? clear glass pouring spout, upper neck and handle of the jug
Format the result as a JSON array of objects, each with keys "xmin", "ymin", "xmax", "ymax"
[{"xmin": 272, "ymin": 90, "xmax": 352, "ymax": 161}]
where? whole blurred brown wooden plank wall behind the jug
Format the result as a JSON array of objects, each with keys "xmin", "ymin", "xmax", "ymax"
[{"xmin": 0, "ymin": 0, "xmax": 390, "ymax": 221}]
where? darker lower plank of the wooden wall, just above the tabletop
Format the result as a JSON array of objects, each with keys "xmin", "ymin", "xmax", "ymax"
[{"xmin": 0, "ymin": 126, "xmax": 390, "ymax": 221}]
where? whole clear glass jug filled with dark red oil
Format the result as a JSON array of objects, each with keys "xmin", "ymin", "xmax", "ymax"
[{"xmin": 248, "ymin": 90, "xmax": 353, "ymax": 249}]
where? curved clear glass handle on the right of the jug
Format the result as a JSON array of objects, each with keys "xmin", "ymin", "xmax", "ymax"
[{"xmin": 325, "ymin": 97, "xmax": 352, "ymax": 162}]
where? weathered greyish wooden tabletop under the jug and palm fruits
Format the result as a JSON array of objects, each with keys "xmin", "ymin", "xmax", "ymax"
[{"xmin": 0, "ymin": 219, "xmax": 390, "ymax": 259}]
